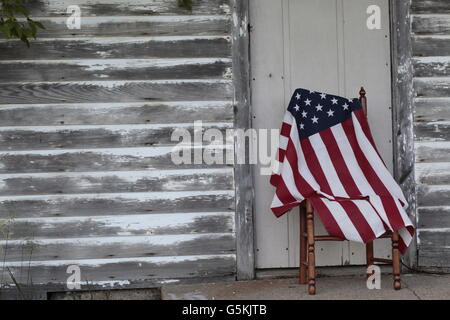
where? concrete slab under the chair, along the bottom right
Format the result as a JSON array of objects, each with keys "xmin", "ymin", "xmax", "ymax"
[{"xmin": 161, "ymin": 274, "xmax": 450, "ymax": 300}]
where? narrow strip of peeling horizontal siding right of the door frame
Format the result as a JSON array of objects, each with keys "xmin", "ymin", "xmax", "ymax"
[{"xmin": 412, "ymin": 0, "xmax": 450, "ymax": 267}]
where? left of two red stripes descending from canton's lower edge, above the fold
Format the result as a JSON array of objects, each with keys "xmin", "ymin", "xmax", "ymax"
[{"xmin": 320, "ymin": 129, "xmax": 361, "ymax": 198}]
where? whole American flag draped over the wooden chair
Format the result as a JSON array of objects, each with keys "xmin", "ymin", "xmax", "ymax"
[{"xmin": 270, "ymin": 89, "xmax": 414, "ymax": 254}]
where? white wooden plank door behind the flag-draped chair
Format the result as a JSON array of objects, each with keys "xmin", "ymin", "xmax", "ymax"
[{"xmin": 250, "ymin": 0, "xmax": 393, "ymax": 268}]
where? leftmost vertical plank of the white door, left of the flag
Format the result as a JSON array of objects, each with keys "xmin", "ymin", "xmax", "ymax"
[{"xmin": 250, "ymin": 0, "xmax": 288, "ymax": 268}]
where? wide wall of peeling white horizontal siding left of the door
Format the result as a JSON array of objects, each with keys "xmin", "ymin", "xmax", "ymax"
[{"xmin": 0, "ymin": 0, "xmax": 236, "ymax": 285}]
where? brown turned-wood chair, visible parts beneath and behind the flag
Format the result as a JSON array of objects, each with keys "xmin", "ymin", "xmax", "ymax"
[{"xmin": 299, "ymin": 88, "xmax": 401, "ymax": 294}]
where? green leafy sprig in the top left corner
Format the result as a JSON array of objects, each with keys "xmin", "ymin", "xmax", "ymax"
[{"xmin": 0, "ymin": 0, "xmax": 45, "ymax": 47}]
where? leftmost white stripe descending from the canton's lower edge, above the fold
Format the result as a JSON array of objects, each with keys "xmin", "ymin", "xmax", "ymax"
[{"xmin": 308, "ymin": 133, "xmax": 348, "ymax": 198}]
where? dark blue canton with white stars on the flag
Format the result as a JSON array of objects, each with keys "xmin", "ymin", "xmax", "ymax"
[{"xmin": 288, "ymin": 89, "xmax": 362, "ymax": 139}]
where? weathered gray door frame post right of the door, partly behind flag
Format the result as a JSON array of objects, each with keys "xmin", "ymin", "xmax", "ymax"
[{"xmin": 389, "ymin": 0, "xmax": 417, "ymax": 267}]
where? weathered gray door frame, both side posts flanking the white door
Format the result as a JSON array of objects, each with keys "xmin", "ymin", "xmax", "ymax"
[{"xmin": 231, "ymin": 0, "xmax": 417, "ymax": 280}]
